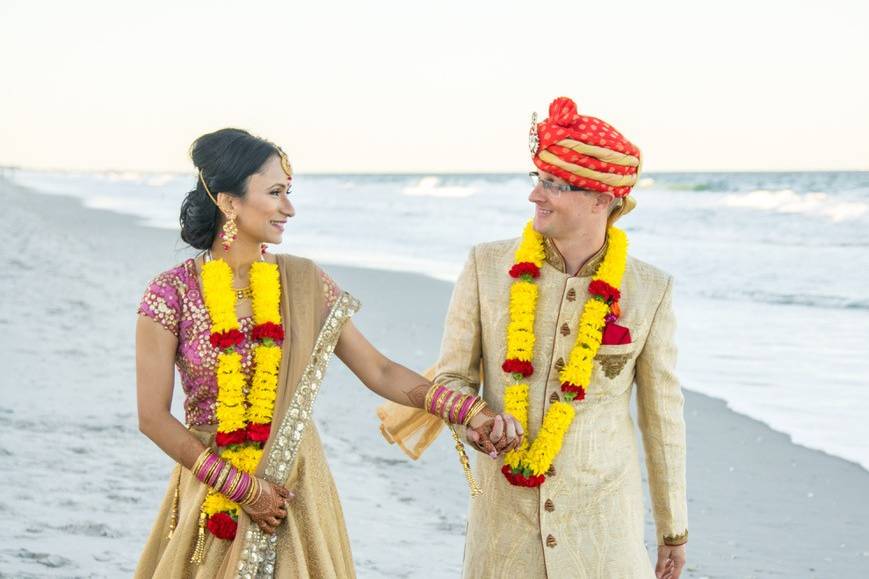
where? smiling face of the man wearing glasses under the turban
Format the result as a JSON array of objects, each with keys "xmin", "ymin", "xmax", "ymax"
[{"xmin": 528, "ymin": 171, "xmax": 611, "ymax": 239}]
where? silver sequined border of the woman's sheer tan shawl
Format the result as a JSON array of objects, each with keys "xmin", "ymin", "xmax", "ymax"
[{"xmin": 237, "ymin": 292, "xmax": 359, "ymax": 577}]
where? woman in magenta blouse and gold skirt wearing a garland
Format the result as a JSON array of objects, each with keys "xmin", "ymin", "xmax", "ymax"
[{"xmin": 136, "ymin": 129, "xmax": 522, "ymax": 578}]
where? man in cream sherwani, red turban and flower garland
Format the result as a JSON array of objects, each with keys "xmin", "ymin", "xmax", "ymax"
[{"xmin": 435, "ymin": 97, "xmax": 688, "ymax": 579}]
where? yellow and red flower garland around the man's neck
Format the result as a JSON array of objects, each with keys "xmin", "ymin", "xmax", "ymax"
[{"xmin": 501, "ymin": 221, "xmax": 628, "ymax": 487}]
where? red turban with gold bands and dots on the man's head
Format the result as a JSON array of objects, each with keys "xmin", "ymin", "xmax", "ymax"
[{"xmin": 531, "ymin": 97, "xmax": 640, "ymax": 197}]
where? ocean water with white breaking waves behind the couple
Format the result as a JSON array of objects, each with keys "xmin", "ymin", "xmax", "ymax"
[{"xmin": 13, "ymin": 171, "xmax": 869, "ymax": 468}]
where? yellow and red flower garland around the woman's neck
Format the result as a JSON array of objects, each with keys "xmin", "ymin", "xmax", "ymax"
[{"xmin": 202, "ymin": 259, "xmax": 284, "ymax": 540}]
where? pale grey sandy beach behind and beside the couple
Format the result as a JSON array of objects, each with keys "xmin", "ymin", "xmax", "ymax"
[{"xmin": 0, "ymin": 177, "xmax": 869, "ymax": 579}]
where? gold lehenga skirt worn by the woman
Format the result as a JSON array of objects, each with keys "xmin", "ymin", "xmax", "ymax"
[{"xmin": 135, "ymin": 422, "xmax": 356, "ymax": 579}]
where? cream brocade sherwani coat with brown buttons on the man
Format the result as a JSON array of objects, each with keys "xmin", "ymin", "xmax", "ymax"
[{"xmin": 435, "ymin": 239, "xmax": 687, "ymax": 579}]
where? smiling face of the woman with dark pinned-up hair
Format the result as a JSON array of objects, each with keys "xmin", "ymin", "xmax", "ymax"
[{"xmin": 233, "ymin": 155, "xmax": 296, "ymax": 244}]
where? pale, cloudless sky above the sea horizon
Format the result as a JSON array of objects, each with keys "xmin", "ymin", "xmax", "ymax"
[{"xmin": 0, "ymin": 0, "xmax": 869, "ymax": 173}]
